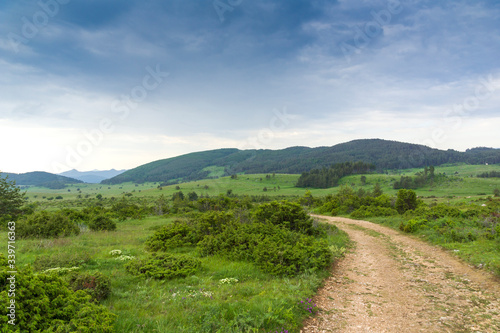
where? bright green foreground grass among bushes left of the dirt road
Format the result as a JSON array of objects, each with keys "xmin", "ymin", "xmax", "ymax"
[{"xmin": 4, "ymin": 216, "xmax": 348, "ymax": 333}]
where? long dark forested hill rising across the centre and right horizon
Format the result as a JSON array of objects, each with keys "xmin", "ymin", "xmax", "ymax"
[{"xmin": 103, "ymin": 139, "xmax": 500, "ymax": 184}]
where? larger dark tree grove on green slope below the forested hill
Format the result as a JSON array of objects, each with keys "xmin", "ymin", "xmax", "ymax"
[{"xmin": 296, "ymin": 162, "xmax": 375, "ymax": 188}]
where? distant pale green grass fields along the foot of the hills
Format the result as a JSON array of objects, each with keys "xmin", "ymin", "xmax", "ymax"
[{"xmin": 23, "ymin": 164, "xmax": 500, "ymax": 202}]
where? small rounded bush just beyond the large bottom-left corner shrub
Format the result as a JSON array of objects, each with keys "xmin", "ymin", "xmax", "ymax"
[{"xmin": 68, "ymin": 272, "xmax": 111, "ymax": 302}]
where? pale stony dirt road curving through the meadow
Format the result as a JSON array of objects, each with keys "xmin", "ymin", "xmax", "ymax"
[{"xmin": 302, "ymin": 216, "xmax": 500, "ymax": 333}]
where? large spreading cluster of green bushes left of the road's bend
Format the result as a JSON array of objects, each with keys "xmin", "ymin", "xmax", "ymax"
[{"xmin": 145, "ymin": 201, "xmax": 332, "ymax": 275}]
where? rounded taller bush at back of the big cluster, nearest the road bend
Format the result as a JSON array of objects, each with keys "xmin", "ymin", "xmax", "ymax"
[{"xmin": 255, "ymin": 201, "xmax": 312, "ymax": 234}]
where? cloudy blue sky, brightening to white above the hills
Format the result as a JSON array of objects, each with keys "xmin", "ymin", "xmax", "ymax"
[{"xmin": 0, "ymin": 0, "xmax": 500, "ymax": 173}]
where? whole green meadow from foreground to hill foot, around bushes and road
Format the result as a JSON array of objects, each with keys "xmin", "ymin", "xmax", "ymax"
[{"xmin": 0, "ymin": 161, "xmax": 500, "ymax": 332}]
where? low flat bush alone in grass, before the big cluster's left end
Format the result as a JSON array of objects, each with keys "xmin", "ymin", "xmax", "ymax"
[{"xmin": 125, "ymin": 253, "xmax": 201, "ymax": 280}]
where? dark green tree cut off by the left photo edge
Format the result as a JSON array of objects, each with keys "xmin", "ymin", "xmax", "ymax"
[{"xmin": 0, "ymin": 175, "xmax": 25, "ymax": 221}]
